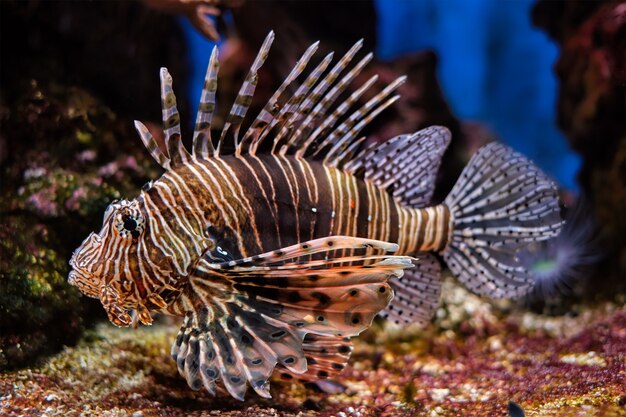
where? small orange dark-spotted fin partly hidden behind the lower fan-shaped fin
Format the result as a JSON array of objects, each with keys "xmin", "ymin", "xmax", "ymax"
[{"xmin": 279, "ymin": 334, "xmax": 353, "ymax": 382}]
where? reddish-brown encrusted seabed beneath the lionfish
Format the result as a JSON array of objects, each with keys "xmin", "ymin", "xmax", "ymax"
[{"xmin": 0, "ymin": 282, "xmax": 626, "ymax": 417}]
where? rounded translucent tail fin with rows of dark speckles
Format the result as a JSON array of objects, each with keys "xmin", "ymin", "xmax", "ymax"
[{"xmin": 442, "ymin": 143, "xmax": 562, "ymax": 298}]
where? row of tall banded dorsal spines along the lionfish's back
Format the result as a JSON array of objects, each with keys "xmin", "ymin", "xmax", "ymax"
[{"xmin": 136, "ymin": 32, "xmax": 405, "ymax": 169}]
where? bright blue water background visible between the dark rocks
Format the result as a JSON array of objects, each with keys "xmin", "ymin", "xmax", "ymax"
[{"xmin": 181, "ymin": 0, "xmax": 581, "ymax": 191}]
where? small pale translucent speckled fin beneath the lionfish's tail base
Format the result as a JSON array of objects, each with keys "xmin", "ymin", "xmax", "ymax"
[{"xmin": 381, "ymin": 253, "xmax": 441, "ymax": 326}]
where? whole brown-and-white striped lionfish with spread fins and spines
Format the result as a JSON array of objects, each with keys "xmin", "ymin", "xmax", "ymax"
[{"xmin": 69, "ymin": 32, "xmax": 562, "ymax": 400}]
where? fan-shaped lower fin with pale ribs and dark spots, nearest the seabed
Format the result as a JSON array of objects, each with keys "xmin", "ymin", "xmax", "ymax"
[{"xmin": 171, "ymin": 268, "xmax": 307, "ymax": 400}]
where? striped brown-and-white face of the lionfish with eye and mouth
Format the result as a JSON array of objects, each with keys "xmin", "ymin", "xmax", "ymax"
[{"xmin": 68, "ymin": 200, "xmax": 166, "ymax": 326}]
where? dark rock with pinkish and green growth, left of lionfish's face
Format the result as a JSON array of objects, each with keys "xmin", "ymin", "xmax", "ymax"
[{"xmin": 0, "ymin": 80, "xmax": 153, "ymax": 369}]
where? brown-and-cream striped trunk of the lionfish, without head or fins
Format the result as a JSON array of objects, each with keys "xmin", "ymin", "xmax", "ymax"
[{"xmin": 141, "ymin": 155, "xmax": 450, "ymax": 275}]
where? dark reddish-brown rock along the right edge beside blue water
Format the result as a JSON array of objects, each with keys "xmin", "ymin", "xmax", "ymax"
[{"xmin": 533, "ymin": 1, "xmax": 626, "ymax": 294}]
